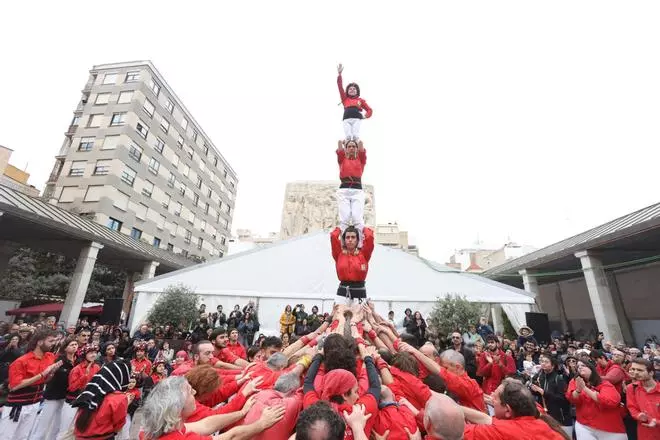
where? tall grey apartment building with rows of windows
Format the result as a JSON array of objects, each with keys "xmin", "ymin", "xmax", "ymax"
[{"xmin": 43, "ymin": 61, "xmax": 238, "ymax": 258}]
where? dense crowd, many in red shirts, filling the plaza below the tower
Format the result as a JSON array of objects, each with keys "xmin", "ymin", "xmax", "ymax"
[{"xmin": 0, "ymin": 303, "xmax": 660, "ymax": 440}]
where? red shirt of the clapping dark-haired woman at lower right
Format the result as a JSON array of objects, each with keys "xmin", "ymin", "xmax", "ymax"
[{"xmin": 566, "ymin": 379, "xmax": 626, "ymax": 433}]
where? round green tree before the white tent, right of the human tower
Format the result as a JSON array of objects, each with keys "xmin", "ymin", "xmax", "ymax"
[{"xmin": 428, "ymin": 295, "xmax": 481, "ymax": 336}]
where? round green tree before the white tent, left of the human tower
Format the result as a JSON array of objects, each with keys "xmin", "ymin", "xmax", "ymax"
[{"xmin": 148, "ymin": 284, "xmax": 199, "ymax": 328}]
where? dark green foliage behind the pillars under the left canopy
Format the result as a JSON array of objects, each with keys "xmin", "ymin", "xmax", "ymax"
[{"xmin": 0, "ymin": 248, "xmax": 126, "ymax": 302}]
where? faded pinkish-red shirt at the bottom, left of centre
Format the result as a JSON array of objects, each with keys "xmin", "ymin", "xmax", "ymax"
[{"xmin": 241, "ymin": 390, "xmax": 303, "ymax": 440}]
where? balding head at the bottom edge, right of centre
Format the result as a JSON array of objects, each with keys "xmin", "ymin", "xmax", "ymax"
[{"xmin": 424, "ymin": 394, "xmax": 465, "ymax": 440}]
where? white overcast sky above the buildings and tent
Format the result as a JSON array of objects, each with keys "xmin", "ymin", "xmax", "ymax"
[{"xmin": 0, "ymin": 1, "xmax": 660, "ymax": 262}]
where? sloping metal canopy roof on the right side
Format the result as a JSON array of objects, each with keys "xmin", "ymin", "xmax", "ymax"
[{"xmin": 481, "ymin": 199, "xmax": 660, "ymax": 286}]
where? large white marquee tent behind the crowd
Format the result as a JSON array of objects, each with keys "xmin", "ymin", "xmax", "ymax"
[{"xmin": 130, "ymin": 231, "xmax": 534, "ymax": 334}]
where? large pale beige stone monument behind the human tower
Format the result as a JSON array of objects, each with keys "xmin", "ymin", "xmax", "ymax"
[{"xmin": 280, "ymin": 181, "xmax": 376, "ymax": 240}]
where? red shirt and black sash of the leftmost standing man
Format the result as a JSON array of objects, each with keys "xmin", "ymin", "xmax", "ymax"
[{"xmin": 7, "ymin": 351, "xmax": 55, "ymax": 406}]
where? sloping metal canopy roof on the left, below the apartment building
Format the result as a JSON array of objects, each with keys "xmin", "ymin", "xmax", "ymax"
[{"xmin": 0, "ymin": 185, "xmax": 195, "ymax": 273}]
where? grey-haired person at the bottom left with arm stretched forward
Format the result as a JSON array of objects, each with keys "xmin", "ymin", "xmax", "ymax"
[{"xmin": 142, "ymin": 377, "xmax": 284, "ymax": 440}]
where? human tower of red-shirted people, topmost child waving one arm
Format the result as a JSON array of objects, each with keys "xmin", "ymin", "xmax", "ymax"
[{"xmin": 330, "ymin": 64, "xmax": 374, "ymax": 304}]
